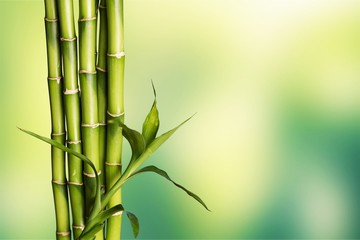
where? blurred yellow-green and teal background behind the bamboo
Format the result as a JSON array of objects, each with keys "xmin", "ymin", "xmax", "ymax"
[{"xmin": 0, "ymin": 0, "xmax": 360, "ymax": 239}]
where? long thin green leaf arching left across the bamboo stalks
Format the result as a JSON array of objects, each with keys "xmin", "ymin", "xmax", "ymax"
[{"xmin": 19, "ymin": 128, "xmax": 101, "ymax": 219}]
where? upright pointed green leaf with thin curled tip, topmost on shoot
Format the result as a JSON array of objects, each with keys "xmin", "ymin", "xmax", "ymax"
[{"xmin": 142, "ymin": 81, "xmax": 160, "ymax": 145}]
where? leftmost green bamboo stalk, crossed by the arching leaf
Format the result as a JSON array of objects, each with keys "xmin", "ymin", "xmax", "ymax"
[{"xmin": 44, "ymin": 0, "xmax": 71, "ymax": 240}]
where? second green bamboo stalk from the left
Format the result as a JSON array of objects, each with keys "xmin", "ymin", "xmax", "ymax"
[{"xmin": 57, "ymin": 0, "xmax": 85, "ymax": 239}]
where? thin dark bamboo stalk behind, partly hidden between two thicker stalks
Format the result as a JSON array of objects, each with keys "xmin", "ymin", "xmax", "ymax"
[{"xmin": 96, "ymin": 0, "xmax": 107, "ymax": 194}]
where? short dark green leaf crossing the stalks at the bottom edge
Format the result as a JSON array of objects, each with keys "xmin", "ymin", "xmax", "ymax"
[{"xmin": 80, "ymin": 204, "xmax": 124, "ymax": 237}]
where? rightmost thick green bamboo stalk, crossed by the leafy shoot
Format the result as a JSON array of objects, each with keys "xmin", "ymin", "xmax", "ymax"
[{"xmin": 105, "ymin": 0, "xmax": 125, "ymax": 240}]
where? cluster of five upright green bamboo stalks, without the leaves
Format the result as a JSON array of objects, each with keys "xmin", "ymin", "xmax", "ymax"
[{"xmin": 45, "ymin": 0, "xmax": 125, "ymax": 240}]
